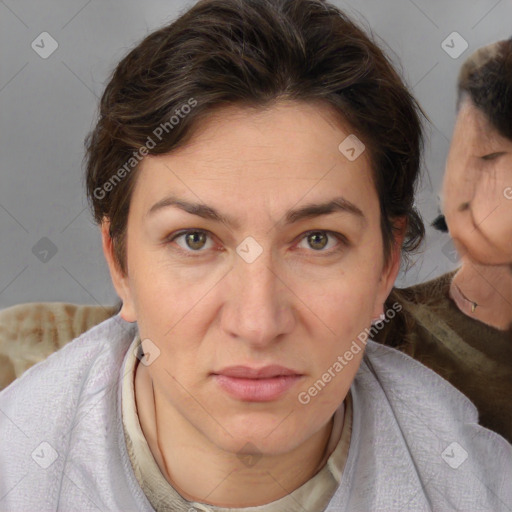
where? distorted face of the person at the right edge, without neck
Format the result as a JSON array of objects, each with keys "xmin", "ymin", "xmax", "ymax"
[{"xmin": 442, "ymin": 99, "xmax": 512, "ymax": 265}]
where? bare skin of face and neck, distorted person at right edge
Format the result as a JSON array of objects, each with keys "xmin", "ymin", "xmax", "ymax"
[{"xmin": 442, "ymin": 98, "xmax": 512, "ymax": 330}]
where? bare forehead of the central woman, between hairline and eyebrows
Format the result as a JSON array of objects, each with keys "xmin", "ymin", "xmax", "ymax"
[{"xmin": 135, "ymin": 104, "xmax": 372, "ymax": 200}]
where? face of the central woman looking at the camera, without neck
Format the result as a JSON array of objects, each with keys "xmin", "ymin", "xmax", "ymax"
[{"xmin": 104, "ymin": 102, "xmax": 399, "ymax": 454}]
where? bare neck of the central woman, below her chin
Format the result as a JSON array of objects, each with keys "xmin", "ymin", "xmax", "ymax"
[{"xmin": 135, "ymin": 364, "xmax": 333, "ymax": 508}]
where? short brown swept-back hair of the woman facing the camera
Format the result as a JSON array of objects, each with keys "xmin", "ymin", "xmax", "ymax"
[{"xmin": 86, "ymin": 0, "xmax": 425, "ymax": 272}]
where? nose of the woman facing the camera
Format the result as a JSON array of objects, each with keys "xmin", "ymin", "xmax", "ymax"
[{"xmin": 221, "ymin": 251, "xmax": 295, "ymax": 348}]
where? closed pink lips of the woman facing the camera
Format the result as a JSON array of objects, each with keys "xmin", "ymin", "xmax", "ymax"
[{"xmin": 213, "ymin": 365, "xmax": 303, "ymax": 402}]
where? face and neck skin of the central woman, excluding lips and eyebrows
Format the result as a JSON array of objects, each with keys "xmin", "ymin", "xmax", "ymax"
[{"xmin": 102, "ymin": 102, "xmax": 403, "ymax": 507}]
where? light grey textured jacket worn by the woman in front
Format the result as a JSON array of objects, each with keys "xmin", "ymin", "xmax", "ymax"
[{"xmin": 0, "ymin": 315, "xmax": 512, "ymax": 512}]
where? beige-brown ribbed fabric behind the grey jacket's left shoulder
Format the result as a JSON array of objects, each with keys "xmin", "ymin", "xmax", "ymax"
[{"xmin": 0, "ymin": 302, "xmax": 118, "ymax": 390}]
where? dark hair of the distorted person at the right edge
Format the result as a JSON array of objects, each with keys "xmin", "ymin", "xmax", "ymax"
[{"xmin": 457, "ymin": 38, "xmax": 512, "ymax": 140}]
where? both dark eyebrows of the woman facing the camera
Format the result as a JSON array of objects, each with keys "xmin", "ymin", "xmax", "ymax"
[{"xmin": 146, "ymin": 195, "xmax": 366, "ymax": 227}]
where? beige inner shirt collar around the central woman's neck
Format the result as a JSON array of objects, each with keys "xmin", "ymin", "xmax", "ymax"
[{"xmin": 121, "ymin": 335, "xmax": 352, "ymax": 512}]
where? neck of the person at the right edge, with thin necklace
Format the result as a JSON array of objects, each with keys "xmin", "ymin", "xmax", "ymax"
[{"xmin": 450, "ymin": 259, "xmax": 512, "ymax": 331}]
